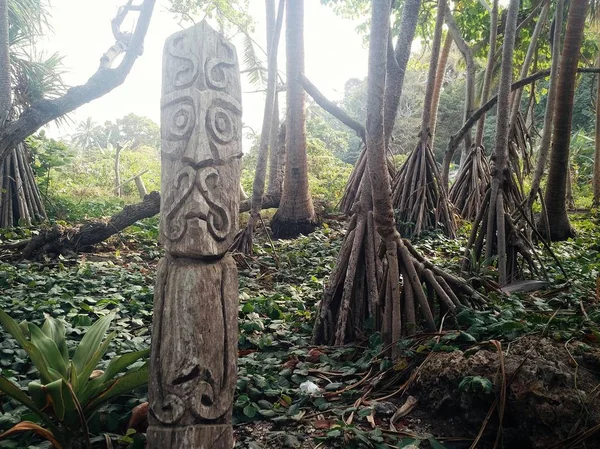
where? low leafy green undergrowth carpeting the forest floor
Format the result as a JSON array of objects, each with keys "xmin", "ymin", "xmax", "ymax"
[{"xmin": 0, "ymin": 214, "xmax": 600, "ymax": 449}]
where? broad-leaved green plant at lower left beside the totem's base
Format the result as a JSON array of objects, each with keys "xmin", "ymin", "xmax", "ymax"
[{"xmin": 0, "ymin": 310, "xmax": 149, "ymax": 449}]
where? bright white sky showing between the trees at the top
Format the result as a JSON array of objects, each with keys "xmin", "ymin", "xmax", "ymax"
[{"xmin": 40, "ymin": 0, "xmax": 368, "ymax": 147}]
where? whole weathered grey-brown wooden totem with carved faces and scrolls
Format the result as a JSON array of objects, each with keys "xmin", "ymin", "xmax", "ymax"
[{"xmin": 147, "ymin": 22, "xmax": 242, "ymax": 449}]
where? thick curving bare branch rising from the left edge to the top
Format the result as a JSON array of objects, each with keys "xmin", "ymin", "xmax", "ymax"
[{"xmin": 0, "ymin": 0, "xmax": 156, "ymax": 161}]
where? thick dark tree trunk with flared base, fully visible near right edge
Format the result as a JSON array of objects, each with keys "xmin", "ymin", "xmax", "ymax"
[{"xmin": 544, "ymin": 0, "xmax": 589, "ymax": 241}]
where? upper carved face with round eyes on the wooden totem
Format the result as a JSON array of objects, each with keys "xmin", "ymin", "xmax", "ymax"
[{"xmin": 161, "ymin": 22, "xmax": 242, "ymax": 257}]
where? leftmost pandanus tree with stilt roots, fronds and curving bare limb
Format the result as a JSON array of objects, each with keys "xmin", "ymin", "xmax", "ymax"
[{"xmin": 0, "ymin": 0, "xmax": 155, "ymax": 226}]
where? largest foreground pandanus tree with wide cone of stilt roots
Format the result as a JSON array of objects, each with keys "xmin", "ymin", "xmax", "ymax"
[{"xmin": 313, "ymin": 0, "xmax": 480, "ymax": 355}]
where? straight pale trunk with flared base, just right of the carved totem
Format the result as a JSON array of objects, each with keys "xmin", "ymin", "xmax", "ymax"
[{"xmin": 271, "ymin": 0, "xmax": 317, "ymax": 238}]
